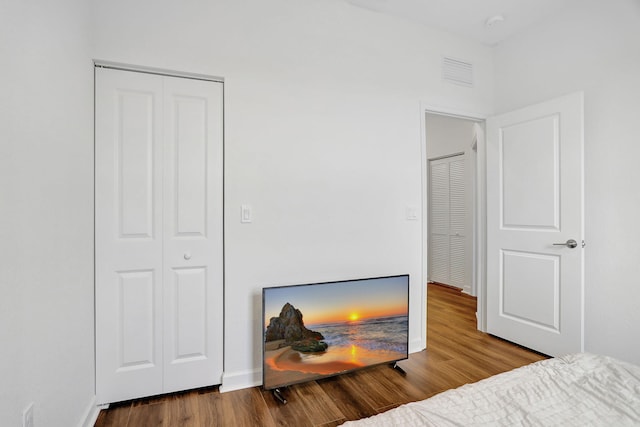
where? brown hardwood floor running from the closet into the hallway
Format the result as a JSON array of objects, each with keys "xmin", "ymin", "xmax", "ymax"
[{"xmin": 96, "ymin": 284, "xmax": 545, "ymax": 427}]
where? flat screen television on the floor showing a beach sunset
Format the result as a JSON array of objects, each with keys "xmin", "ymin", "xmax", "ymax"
[{"xmin": 262, "ymin": 275, "xmax": 409, "ymax": 390}]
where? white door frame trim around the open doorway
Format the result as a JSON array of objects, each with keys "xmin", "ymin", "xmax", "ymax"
[{"xmin": 420, "ymin": 102, "xmax": 489, "ymax": 336}]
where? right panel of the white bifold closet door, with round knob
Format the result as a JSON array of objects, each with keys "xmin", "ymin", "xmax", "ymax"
[{"xmin": 164, "ymin": 78, "xmax": 223, "ymax": 391}]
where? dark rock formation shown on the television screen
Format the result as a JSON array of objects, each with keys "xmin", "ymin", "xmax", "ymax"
[{"xmin": 264, "ymin": 303, "xmax": 328, "ymax": 352}]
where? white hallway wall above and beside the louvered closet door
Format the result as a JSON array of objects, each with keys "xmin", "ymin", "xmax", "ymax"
[{"xmin": 425, "ymin": 113, "xmax": 476, "ymax": 295}]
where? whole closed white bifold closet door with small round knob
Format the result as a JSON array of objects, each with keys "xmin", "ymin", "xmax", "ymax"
[{"xmin": 95, "ymin": 68, "xmax": 223, "ymax": 403}]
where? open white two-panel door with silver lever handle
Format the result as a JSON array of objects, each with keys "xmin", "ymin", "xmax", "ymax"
[{"xmin": 487, "ymin": 93, "xmax": 584, "ymax": 356}]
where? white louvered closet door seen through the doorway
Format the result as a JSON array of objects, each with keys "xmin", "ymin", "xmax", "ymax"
[{"xmin": 429, "ymin": 155, "xmax": 469, "ymax": 289}]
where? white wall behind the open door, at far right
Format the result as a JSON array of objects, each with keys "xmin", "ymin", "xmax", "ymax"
[{"xmin": 494, "ymin": 0, "xmax": 640, "ymax": 364}]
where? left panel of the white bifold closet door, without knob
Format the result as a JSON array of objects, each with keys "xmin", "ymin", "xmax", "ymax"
[{"xmin": 95, "ymin": 69, "xmax": 164, "ymax": 403}]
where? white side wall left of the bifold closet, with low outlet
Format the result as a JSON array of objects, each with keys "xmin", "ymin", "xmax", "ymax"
[{"xmin": 0, "ymin": 0, "xmax": 94, "ymax": 426}]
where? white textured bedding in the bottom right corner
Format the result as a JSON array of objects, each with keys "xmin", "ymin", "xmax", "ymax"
[{"xmin": 343, "ymin": 353, "xmax": 640, "ymax": 427}]
